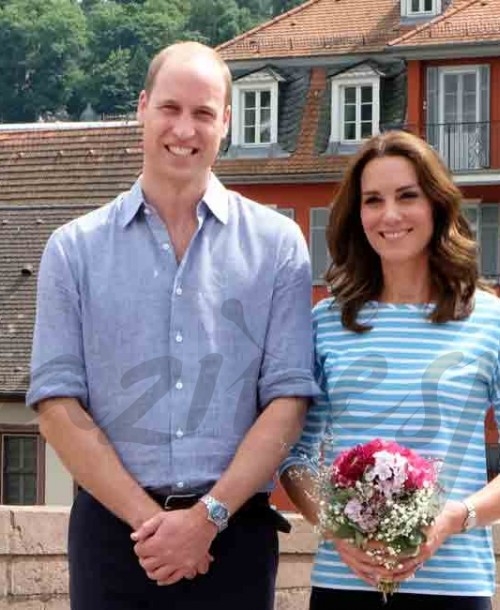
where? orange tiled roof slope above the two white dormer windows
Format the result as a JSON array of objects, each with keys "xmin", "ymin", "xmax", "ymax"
[{"xmin": 218, "ymin": 0, "xmax": 404, "ymax": 61}]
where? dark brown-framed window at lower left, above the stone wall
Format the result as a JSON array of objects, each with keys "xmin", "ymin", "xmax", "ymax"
[{"xmin": 0, "ymin": 426, "xmax": 45, "ymax": 505}]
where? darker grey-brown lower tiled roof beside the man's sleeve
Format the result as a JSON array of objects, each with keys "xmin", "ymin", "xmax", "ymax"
[{"xmin": 0, "ymin": 205, "xmax": 96, "ymax": 393}]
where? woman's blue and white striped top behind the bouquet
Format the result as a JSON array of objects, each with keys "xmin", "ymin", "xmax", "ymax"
[{"xmin": 281, "ymin": 291, "xmax": 500, "ymax": 596}]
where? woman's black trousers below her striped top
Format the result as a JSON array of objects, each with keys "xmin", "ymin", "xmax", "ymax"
[{"xmin": 309, "ymin": 587, "xmax": 491, "ymax": 610}]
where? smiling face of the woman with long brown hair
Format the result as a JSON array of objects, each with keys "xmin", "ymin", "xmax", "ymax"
[{"xmin": 361, "ymin": 156, "xmax": 434, "ymax": 265}]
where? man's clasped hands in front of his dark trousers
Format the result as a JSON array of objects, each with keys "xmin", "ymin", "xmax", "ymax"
[{"xmin": 131, "ymin": 504, "xmax": 217, "ymax": 585}]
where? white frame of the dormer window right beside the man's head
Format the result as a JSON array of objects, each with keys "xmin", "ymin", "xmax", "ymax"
[{"xmin": 231, "ymin": 73, "xmax": 282, "ymax": 148}]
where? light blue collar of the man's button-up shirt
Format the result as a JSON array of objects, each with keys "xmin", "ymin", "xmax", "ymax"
[{"xmin": 121, "ymin": 173, "xmax": 229, "ymax": 228}]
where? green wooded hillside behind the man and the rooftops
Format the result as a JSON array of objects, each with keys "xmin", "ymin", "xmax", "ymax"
[{"xmin": 0, "ymin": 0, "xmax": 300, "ymax": 122}]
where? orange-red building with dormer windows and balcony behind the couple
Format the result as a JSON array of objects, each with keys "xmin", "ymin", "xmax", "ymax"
[{"xmin": 217, "ymin": 0, "xmax": 500, "ymax": 504}]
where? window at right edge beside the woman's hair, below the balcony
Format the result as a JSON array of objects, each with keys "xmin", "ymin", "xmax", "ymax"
[{"xmin": 462, "ymin": 203, "xmax": 500, "ymax": 279}]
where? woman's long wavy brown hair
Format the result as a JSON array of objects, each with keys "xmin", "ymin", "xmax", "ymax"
[{"xmin": 325, "ymin": 131, "xmax": 483, "ymax": 333}]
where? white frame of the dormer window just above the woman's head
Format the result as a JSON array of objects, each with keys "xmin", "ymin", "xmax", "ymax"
[{"xmin": 330, "ymin": 75, "xmax": 380, "ymax": 144}]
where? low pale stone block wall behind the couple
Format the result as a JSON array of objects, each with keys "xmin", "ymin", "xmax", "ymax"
[{"xmin": 0, "ymin": 506, "xmax": 500, "ymax": 610}]
